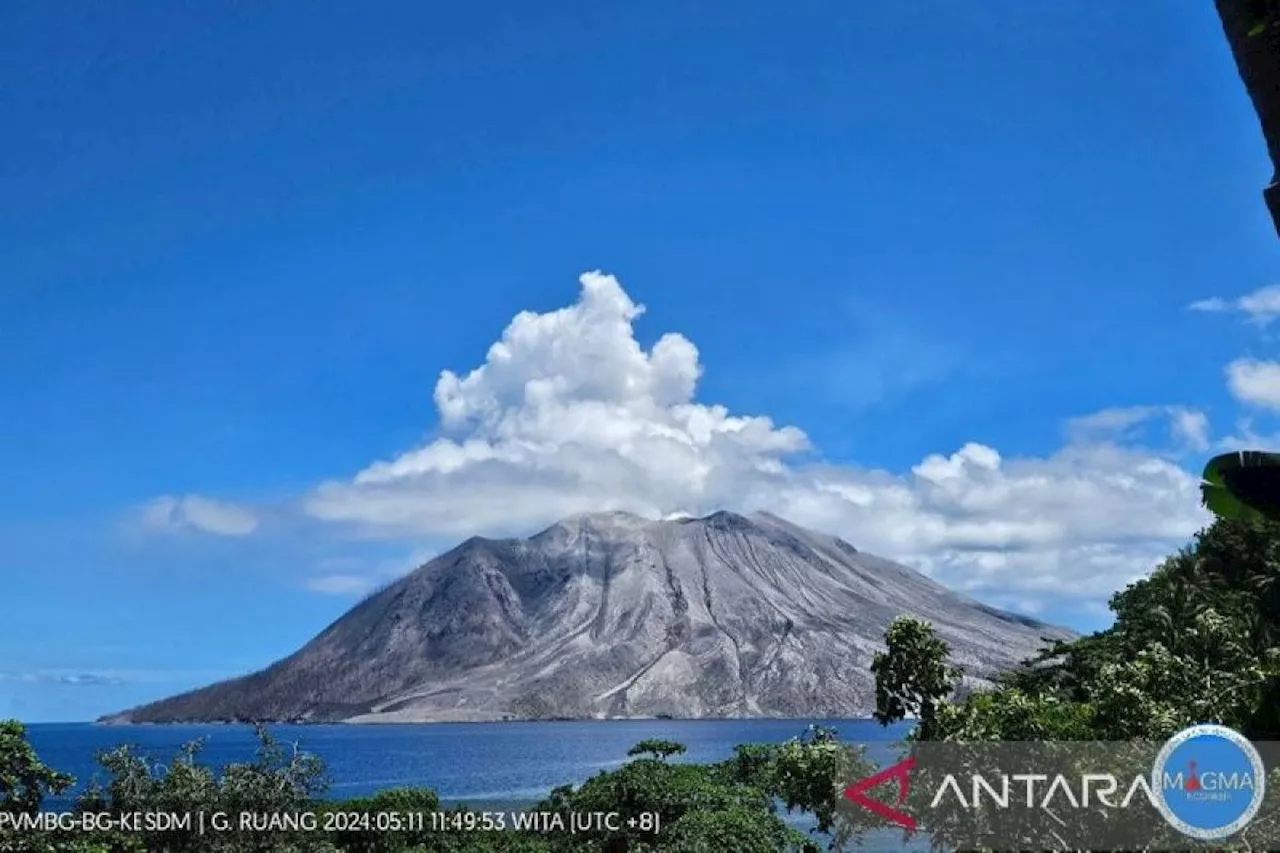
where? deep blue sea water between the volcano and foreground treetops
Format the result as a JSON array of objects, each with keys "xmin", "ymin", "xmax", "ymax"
[{"xmin": 28, "ymin": 720, "xmax": 908, "ymax": 808}]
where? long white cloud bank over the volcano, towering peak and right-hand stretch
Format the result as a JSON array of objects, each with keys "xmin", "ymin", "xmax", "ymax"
[{"xmin": 306, "ymin": 273, "xmax": 1208, "ymax": 606}]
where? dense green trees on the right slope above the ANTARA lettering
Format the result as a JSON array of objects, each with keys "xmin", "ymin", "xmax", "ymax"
[{"xmin": 874, "ymin": 515, "xmax": 1280, "ymax": 849}]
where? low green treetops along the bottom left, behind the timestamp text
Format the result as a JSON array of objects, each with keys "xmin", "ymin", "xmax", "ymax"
[{"xmin": 0, "ymin": 722, "xmax": 865, "ymax": 853}]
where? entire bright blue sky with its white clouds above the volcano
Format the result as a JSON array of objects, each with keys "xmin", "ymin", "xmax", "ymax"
[{"xmin": 0, "ymin": 0, "xmax": 1280, "ymax": 721}]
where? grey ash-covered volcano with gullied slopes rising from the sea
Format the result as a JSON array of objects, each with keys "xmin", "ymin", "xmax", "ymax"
[{"xmin": 105, "ymin": 512, "xmax": 1071, "ymax": 722}]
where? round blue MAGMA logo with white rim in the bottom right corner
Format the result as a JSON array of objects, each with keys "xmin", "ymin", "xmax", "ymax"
[{"xmin": 1151, "ymin": 724, "xmax": 1266, "ymax": 841}]
